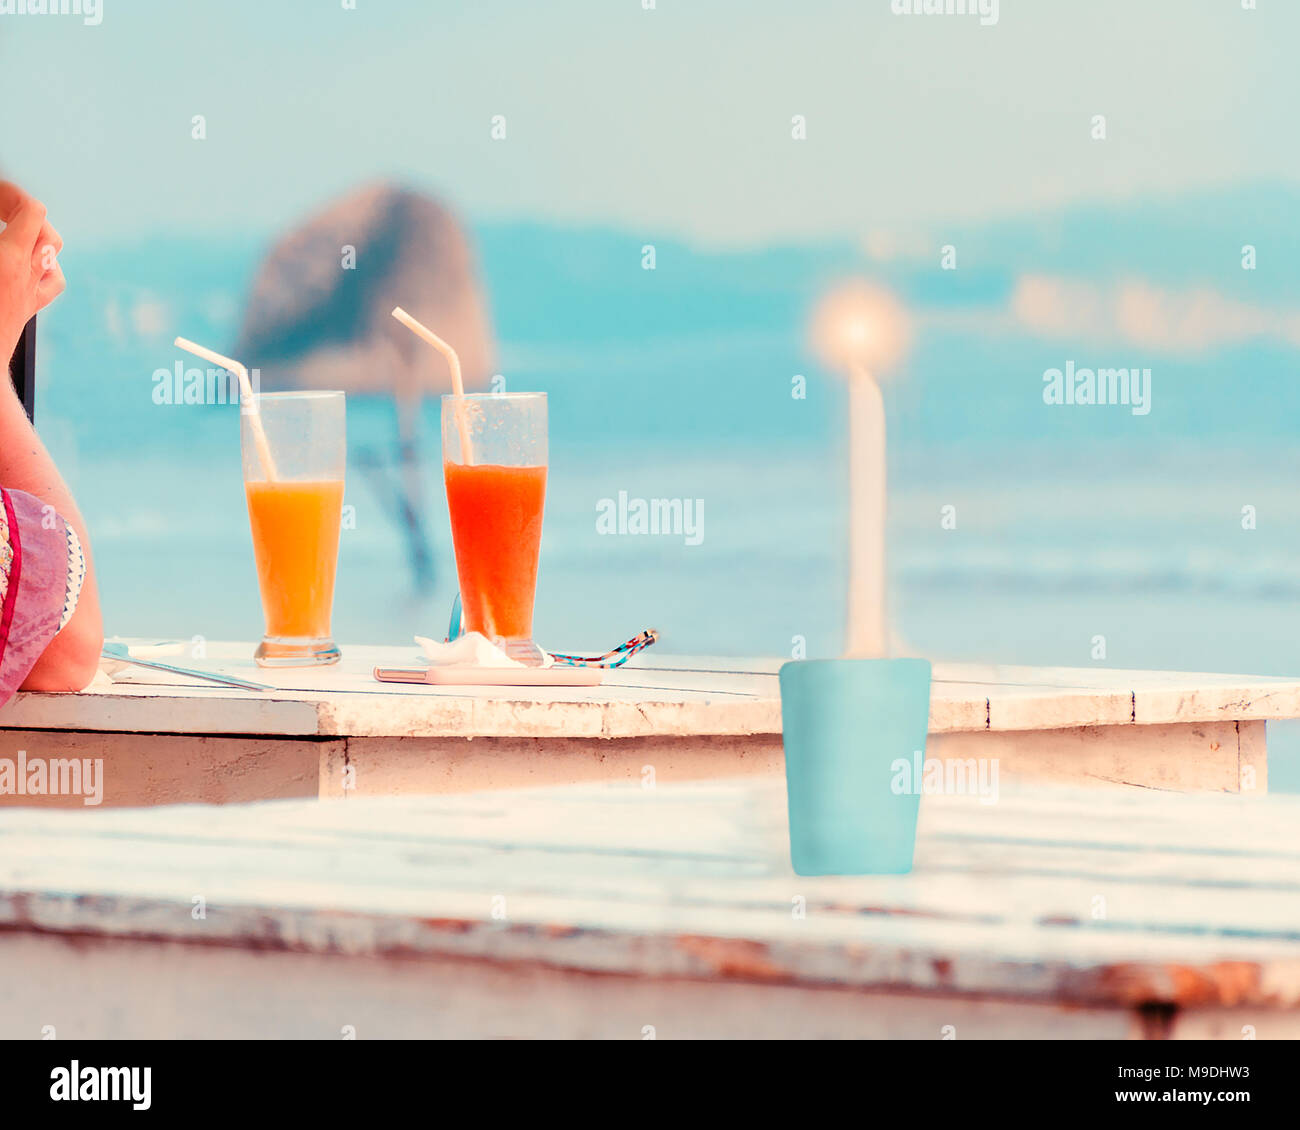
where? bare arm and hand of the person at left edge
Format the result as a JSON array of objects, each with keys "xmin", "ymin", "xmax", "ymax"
[{"xmin": 0, "ymin": 183, "xmax": 104, "ymax": 690}]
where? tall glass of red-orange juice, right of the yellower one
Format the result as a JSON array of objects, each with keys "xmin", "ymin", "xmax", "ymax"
[{"xmin": 442, "ymin": 393, "xmax": 547, "ymax": 664}]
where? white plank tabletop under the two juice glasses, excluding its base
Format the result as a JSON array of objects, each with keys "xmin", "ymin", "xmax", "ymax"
[{"xmin": 0, "ymin": 642, "xmax": 1300, "ymax": 739}]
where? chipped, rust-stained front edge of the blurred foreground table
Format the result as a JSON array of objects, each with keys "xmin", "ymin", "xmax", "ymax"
[{"xmin": 0, "ymin": 887, "xmax": 1300, "ymax": 1009}]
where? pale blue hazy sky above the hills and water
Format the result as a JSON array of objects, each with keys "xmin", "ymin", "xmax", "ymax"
[{"xmin": 0, "ymin": 0, "xmax": 1300, "ymax": 243}]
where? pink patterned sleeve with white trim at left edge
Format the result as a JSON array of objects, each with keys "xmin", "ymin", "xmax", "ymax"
[{"xmin": 0, "ymin": 489, "xmax": 86, "ymax": 706}]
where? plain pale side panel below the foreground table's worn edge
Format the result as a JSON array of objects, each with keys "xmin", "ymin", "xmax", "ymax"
[{"xmin": 0, "ymin": 934, "xmax": 1141, "ymax": 1040}]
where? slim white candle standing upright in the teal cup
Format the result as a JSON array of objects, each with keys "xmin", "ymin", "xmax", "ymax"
[{"xmin": 845, "ymin": 364, "xmax": 888, "ymax": 659}]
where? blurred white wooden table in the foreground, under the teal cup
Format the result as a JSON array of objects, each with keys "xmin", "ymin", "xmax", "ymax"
[{"xmin": 0, "ymin": 782, "xmax": 1300, "ymax": 1039}]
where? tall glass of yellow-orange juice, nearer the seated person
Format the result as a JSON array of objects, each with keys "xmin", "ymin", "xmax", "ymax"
[{"xmin": 241, "ymin": 393, "xmax": 347, "ymax": 667}]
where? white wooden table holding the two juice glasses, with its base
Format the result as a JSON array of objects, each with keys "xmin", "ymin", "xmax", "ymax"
[{"xmin": 0, "ymin": 642, "xmax": 1300, "ymax": 805}]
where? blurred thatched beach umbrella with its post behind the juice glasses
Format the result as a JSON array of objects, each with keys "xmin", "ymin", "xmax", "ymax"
[{"xmin": 234, "ymin": 185, "xmax": 493, "ymax": 594}]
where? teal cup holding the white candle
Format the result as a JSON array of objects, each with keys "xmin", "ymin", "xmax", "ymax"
[{"xmin": 780, "ymin": 659, "xmax": 930, "ymax": 875}]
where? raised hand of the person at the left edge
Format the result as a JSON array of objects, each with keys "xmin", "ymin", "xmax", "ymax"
[{"xmin": 0, "ymin": 181, "xmax": 66, "ymax": 361}]
